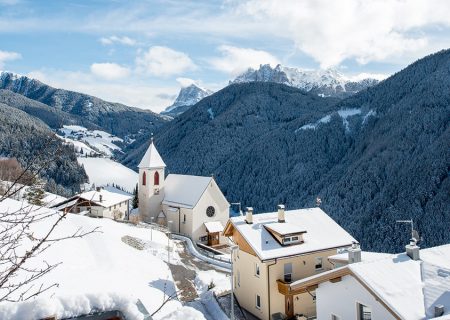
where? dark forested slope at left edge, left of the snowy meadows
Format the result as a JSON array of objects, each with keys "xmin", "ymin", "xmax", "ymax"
[{"xmin": 0, "ymin": 103, "xmax": 87, "ymax": 195}]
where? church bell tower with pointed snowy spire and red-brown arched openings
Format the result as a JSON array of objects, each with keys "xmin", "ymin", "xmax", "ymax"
[{"xmin": 138, "ymin": 137, "xmax": 166, "ymax": 222}]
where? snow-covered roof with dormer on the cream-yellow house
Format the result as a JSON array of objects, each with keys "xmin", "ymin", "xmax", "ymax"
[{"xmin": 230, "ymin": 208, "xmax": 356, "ymax": 260}]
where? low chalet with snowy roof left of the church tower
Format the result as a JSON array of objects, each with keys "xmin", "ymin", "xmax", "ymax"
[{"xmin": 52, "ymin": 188, "xmax": 132, "ymax": 220}]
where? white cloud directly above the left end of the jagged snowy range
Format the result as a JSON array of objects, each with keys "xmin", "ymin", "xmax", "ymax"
[{"xmin": 208, "ymin": 45, "xmax": 279, "ymax": 76}]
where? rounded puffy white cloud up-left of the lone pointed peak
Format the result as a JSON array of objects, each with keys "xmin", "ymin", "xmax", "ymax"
[{"xmin": 136, "ymin": 46, "xmax": 197, "ymax": 77}]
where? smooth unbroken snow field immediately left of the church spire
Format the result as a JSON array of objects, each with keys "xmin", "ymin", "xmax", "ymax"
[{"xmin": 78, "ymin": 157, "xmax": 138, "ymax": 193}]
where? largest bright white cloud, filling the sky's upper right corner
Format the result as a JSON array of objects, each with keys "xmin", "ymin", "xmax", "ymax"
[{"xmin": 237, "ymin": 0, "xmax": 450, "ymax": 68}]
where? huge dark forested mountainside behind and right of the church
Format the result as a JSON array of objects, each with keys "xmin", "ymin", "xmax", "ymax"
[{"xmin": 124, "ymin": 50, "xmax": 450, "ymax": 252}]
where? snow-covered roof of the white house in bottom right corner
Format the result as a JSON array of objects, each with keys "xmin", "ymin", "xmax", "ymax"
[{"xmin": 349, "ymin": 245, "xmax": 450, "ymax": 319}]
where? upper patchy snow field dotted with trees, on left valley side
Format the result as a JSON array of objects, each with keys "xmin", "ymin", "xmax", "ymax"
[{"xmin": 59, "ymin": 125, "xmax": 123, "ymax": 157}]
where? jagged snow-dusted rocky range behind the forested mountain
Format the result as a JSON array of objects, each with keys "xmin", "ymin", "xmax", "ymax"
[{"xmin": 230, "ymin": 64, "xmax": 378, "ymax": 96}]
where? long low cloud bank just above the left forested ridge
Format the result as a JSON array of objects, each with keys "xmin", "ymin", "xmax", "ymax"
[{"xmin": 27, "ymin": 69, "xmax": 179, "ymax": 112}]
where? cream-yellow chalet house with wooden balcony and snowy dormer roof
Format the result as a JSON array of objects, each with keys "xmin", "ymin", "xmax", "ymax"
[{"xmin": 224, "ymin": 205, "xmax": 355, "ymax": 319}]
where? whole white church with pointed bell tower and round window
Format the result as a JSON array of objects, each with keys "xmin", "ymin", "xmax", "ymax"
[{"xmin": 138, "ymin": 138, "xmax": 230, "ymax": 246}]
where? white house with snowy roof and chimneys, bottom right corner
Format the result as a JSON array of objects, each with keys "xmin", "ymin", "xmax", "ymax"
[{"xmin": 289, "ymin": 240, "xmax": 450, "ymax": 320}]
